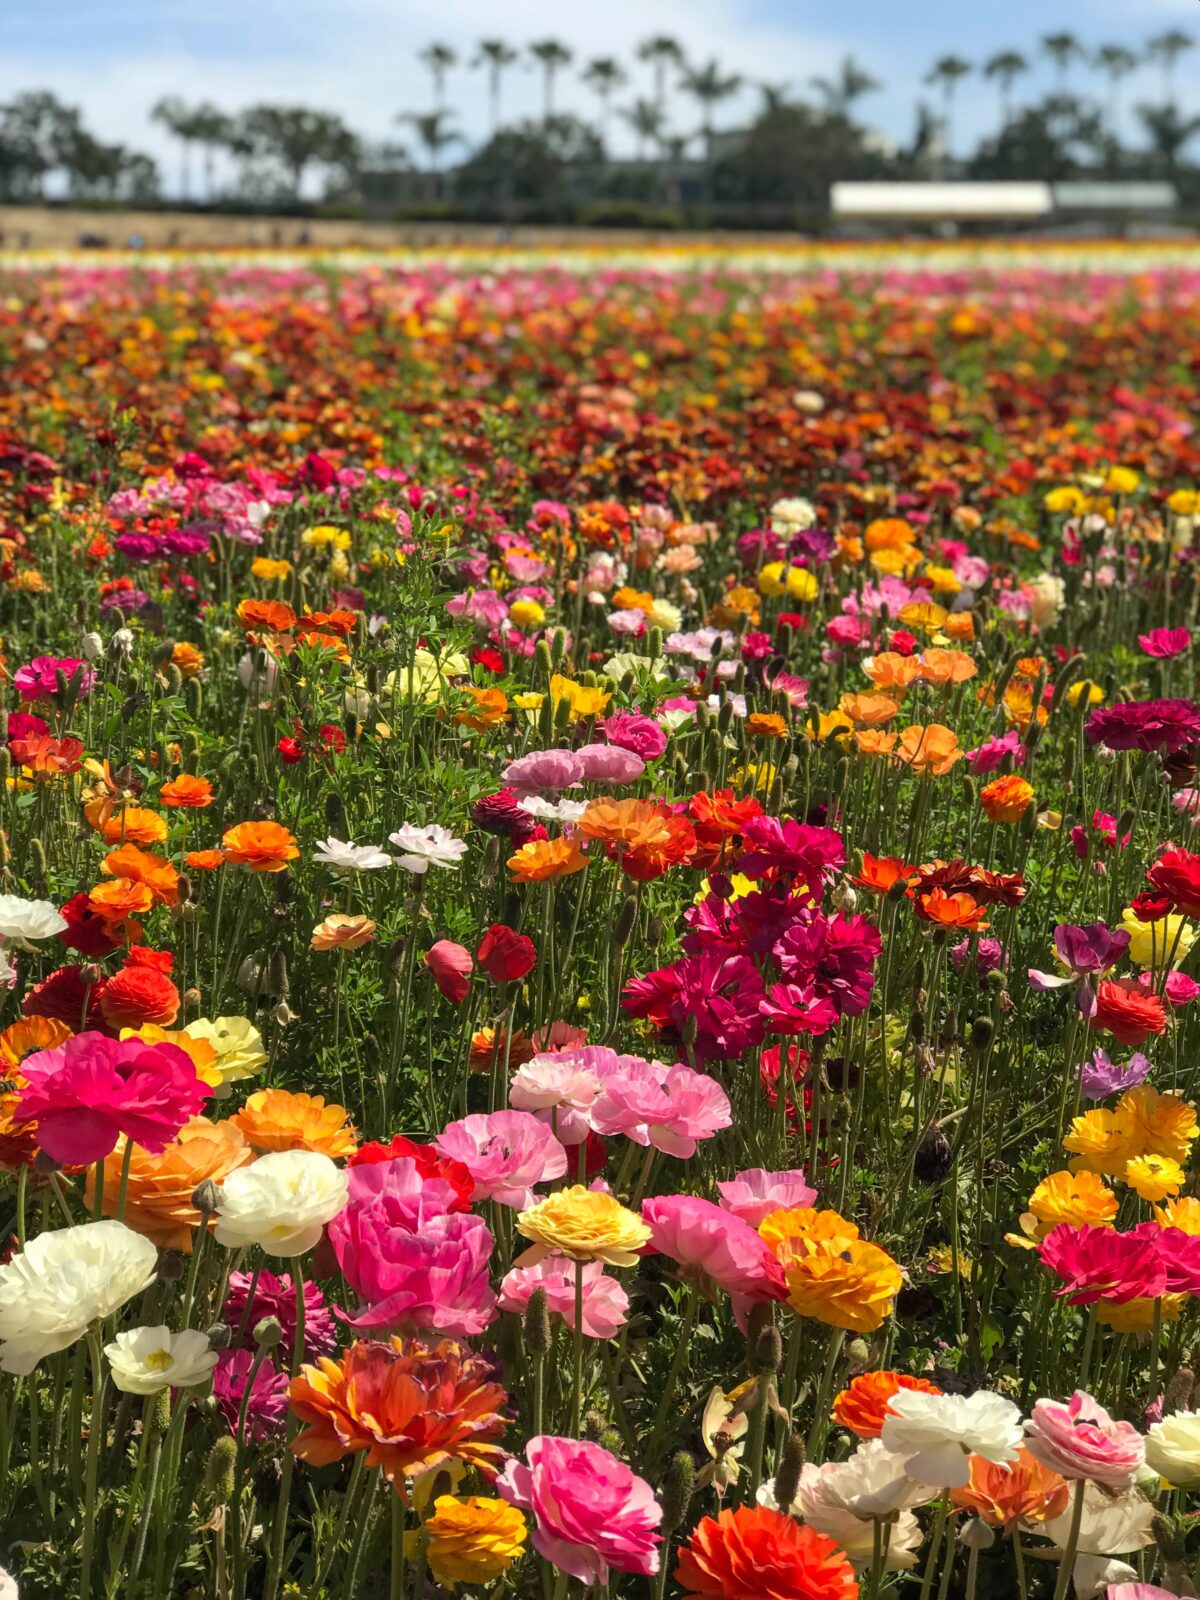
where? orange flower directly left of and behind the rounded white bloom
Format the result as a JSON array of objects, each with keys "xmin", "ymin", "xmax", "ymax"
[{"xmin": 86, "ymin": 1117, "xmax": 254, "ymax": 1254}]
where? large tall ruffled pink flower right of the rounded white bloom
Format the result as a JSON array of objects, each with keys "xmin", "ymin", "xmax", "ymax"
[{"xmin": 330, "ymin": 1155, "xmax": 496, "ymax": 1338}]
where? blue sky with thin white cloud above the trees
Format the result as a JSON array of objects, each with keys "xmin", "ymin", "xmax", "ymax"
[{"xmin": 0, "ymin": 0, "xmax": 1200, "ymax": 184}]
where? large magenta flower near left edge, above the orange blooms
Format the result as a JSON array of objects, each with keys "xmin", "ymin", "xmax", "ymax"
[{"xmin": 14, "ymin": 1032, "xmax": 213, "ymax": 1166}]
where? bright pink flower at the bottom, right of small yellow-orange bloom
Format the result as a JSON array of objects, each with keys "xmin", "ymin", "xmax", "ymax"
[{"xmin": 496, "ymin": 1434, "xmax": 662, "ymax": 1584}]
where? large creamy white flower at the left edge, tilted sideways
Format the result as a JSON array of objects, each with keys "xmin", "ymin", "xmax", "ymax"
[{"xmin": 0, "ymin": 1221, "xmax": 158, "ymax": 1376}]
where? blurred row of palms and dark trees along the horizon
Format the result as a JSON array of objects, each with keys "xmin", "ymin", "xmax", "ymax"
[{"xmin": 0, "ymin": 29, "xmax": 1200, "ymax": 210}]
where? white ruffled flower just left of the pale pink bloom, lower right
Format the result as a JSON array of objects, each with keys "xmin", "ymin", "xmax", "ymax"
[{"xmin": 880, "ymin": 1389, "xmax": 1024, "ymax": 1490}]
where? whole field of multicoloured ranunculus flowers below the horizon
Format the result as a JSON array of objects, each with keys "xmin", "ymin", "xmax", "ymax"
[{"xmin": 0, "ymin": 248, "xmax": 1200, "ymax": 1600}]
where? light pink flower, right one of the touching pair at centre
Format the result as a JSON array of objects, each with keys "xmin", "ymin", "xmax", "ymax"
[{"xmin": 592, "ymin": 1056, "xmax": 733, "ymax": 1160}]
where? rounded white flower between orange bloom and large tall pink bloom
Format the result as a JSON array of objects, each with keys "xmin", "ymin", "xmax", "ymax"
[{"xmin": 216, "ymin": 1150, "xmax": 349, "ymax": 1256}]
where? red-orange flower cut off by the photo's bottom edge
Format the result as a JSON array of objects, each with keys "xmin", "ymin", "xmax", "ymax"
[{"xmin": 675, "ymin": 1506, "xmax": 859, "ymax": 1600}]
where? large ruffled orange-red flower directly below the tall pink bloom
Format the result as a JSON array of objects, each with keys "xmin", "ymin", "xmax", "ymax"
[{"xmin": 288, "ymin": 1338, "xmax": 509, "ymax": 1504}]
